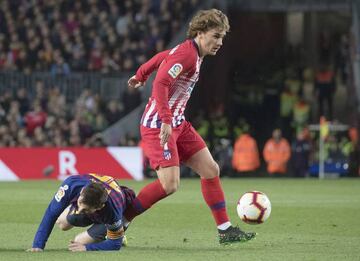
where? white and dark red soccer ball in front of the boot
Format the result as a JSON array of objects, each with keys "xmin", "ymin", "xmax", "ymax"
[{"xmin": 236, "ymin": 191, "xmax": 271, "ymax": 225}]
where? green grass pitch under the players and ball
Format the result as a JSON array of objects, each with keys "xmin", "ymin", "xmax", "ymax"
[{"xmin": 0, "ymin": 178, "xmax": 360, "ymax": 261}]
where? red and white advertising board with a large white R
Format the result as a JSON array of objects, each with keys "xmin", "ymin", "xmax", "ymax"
[{"xmin": 0, "ymin": 147, "xmax": 143, "ymax": 181}]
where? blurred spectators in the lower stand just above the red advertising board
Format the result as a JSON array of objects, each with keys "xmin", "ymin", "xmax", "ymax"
[{"xmin": 0, "ymin": 81, "xmax": 141, "ymax": 147}]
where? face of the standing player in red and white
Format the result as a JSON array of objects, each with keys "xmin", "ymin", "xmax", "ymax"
[{"xmin": 198, "ymin": 28, "xmax": 226, "ymax": 56}]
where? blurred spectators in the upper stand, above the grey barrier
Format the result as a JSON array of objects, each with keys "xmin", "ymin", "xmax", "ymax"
[{"xmin": 0, "ymin": 0, "xmax": 199, "ymax": 75}]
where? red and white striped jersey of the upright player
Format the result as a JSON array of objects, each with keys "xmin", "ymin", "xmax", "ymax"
[{"xmin": 136, "ymin": 40, "xmax": 202, "ymax": 128}]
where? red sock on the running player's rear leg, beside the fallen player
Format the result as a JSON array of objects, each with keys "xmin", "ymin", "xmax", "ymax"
[{"xmin": 124, "ymin": 179, "xmax": 167, "ymax": 221}]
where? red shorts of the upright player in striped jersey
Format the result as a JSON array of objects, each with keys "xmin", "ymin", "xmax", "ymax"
[{"xmin": 140, "ymin": 121, "xmax": 206, "ymax": 170}]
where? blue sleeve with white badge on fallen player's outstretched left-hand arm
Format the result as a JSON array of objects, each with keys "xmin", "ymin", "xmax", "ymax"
[{"xmin": 32, "ymin": 179, "xmax": 71, "ymax": 249}]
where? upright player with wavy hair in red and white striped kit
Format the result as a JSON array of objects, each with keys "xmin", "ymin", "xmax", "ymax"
[{"xmin": 124, "ymin": 9, "xmax": 256, "ymax": 244}]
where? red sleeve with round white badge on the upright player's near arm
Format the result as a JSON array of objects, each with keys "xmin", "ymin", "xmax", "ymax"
[{"xmin": 152, "ymin": 50, "xmax": 196, "ymax": 124}]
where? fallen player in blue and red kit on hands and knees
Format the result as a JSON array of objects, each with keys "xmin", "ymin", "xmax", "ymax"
[{"xmin": 28, "ymin": 174, "xmax": 135, "ymax": 252}]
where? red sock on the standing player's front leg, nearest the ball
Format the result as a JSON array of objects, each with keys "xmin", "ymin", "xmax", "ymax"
[{"xmin": 201, "ymin": 176, "xmax": 229, "ymax": 225}]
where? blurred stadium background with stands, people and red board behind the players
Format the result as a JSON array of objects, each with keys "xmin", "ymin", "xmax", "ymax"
[{"xmin": 0, "ymin": 0, "xmax": 360, "ymax": 180}]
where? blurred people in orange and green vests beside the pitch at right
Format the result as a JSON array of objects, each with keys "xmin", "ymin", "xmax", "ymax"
[{"xmin": 187, "ymin": 110, "xmax": 360, "ymax": 177}]
